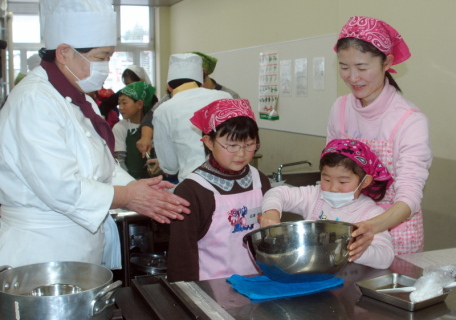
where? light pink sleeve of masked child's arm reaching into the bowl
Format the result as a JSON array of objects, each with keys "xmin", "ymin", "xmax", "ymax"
[{"xmin": 261, "ymin": 186, "xmax": 318, "ymax": 219}]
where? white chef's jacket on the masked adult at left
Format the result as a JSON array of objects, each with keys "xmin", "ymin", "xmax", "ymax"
[{"xmin": 0, "ymin": 67, "xmax": 133, "ymax": 267}]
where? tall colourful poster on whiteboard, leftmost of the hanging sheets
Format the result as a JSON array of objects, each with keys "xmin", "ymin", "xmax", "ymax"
[{"xmin": 258, "ymin": 52, "xmax": 279, "ymax": 120}]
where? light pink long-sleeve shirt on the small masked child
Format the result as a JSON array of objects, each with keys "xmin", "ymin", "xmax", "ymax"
[{"xmin": 261, "ymin": 186, "xmax": 394, "ymax": 269}]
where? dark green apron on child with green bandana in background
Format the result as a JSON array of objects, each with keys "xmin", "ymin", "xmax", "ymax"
[{"xmin": 125, "ymin": 129, "xmax": 149, "ymax": 179}]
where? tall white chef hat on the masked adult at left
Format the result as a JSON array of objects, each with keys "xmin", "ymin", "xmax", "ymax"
[{"xmin": 40, "ymin": 0, "xmax": 117, "ymax": 50}]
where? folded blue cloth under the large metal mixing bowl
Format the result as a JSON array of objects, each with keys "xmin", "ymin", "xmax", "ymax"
[{"xmin": 226, "ymin": 274, "xmax": 344, "ymax": 300}]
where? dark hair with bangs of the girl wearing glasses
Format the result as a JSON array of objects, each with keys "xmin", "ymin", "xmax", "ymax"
[{"xmin": 203, "ymin": 116, "xmax": 260, "ymax": 155}]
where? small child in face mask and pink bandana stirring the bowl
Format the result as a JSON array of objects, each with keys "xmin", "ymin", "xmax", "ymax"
[{"xmin": 260, "ymin": 139, "xmax": 394, "ymax": 269}]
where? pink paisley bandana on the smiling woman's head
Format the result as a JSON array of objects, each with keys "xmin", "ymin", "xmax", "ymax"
[{"xmin": 334, "ymin": 17, "xmax": 411, "ymax": 73}]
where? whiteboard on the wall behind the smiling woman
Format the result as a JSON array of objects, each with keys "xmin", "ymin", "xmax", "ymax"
[{"xmin": 210, "ymin": 34, "xmax": 338, "ymax": 137}]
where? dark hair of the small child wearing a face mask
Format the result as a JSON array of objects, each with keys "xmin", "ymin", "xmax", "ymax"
[{"xmin": 320, "ymin": 152, "xmax": 388, "ymax": 201}]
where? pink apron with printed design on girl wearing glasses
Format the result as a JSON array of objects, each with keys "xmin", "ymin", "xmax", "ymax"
[{"xmin": 187, "ymin": 166, "xmax": 263, "ymax": 280}]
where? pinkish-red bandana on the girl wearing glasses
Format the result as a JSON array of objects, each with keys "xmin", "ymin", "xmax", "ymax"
[{"xmin": 190, "ymin": 99, "xmax": 255, "ymax": 134}]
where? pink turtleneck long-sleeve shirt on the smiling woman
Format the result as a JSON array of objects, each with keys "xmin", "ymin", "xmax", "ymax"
[{"xmin": 327, "ymin": 80, "xmax": 432, "ymax": 214}]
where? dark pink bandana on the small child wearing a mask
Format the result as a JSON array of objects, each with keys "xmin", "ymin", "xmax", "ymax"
[{"xmin": 321, "ymin": 139, "xmax": 394, "ymax": 196}]
